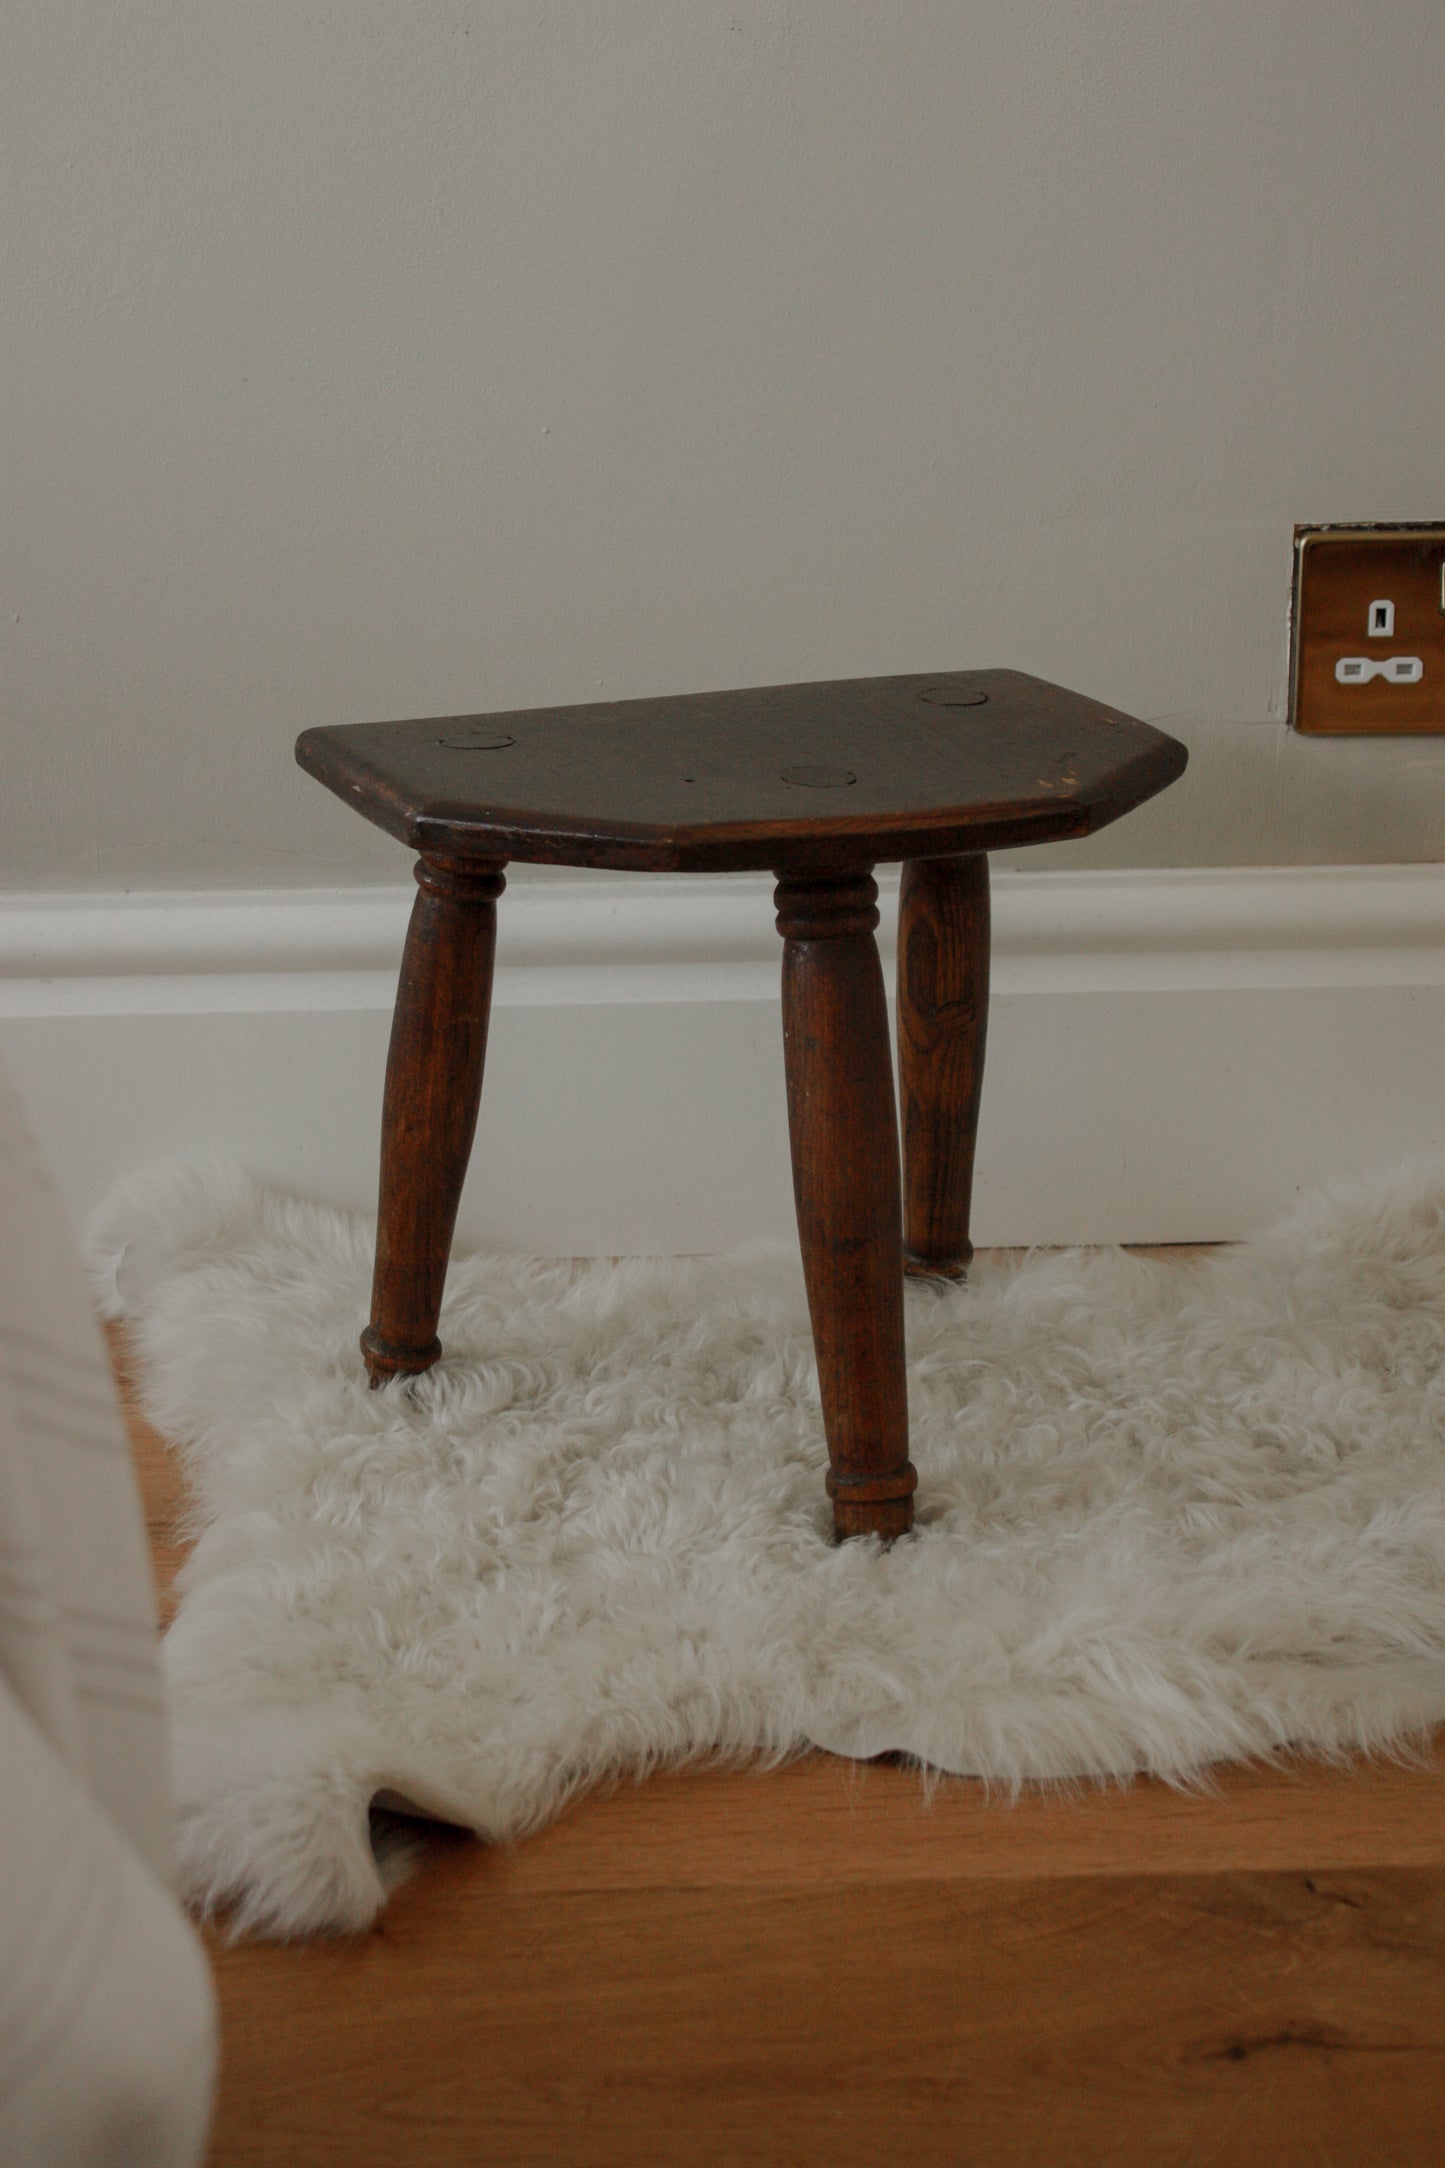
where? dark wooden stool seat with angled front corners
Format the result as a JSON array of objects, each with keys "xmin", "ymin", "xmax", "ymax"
[{"xmin": 297, "ymin": 670, "xmax": 1187, "ymax": 872}]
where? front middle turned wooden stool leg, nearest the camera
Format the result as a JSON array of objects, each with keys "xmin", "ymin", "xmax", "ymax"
[{"xmin": 776, "ymin": 874, "xmax": 919, "ymax": 1539}]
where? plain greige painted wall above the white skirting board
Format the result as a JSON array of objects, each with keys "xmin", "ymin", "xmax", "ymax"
[{"xmin": 0, "ymin": 0, "xmax": 1445, "ymax": 889}]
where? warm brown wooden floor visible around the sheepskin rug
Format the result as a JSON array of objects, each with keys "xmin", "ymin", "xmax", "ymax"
[{"xmin": 110, "ymin": 1274, "xmax": 1445, "ymax": 2168}]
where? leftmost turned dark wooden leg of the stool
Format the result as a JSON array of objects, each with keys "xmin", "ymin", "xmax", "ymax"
[{"xmin": 362, "ymin": 856, "xmax": 505, "ymax": 1385}]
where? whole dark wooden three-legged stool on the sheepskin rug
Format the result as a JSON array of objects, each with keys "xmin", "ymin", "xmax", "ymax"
[{"xmin": 297, "ymin": 670, "xmax": 1185, "ymax": 1539}]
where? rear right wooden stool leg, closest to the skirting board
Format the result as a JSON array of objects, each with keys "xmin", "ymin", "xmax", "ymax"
[{"xmin": 899, "ymin": 850, "xmax": 988, "ymax": 1279}]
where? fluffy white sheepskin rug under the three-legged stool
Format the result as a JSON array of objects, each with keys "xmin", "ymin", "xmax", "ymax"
[{"xmin": 93, "ymin": 1162, "xmax": 1445, "ymax": 1934}]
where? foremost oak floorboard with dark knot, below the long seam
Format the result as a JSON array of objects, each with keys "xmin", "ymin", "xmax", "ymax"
[{"xmin": 191, "ymin": 1860, "xmax": 1445, "ymax": 2168}]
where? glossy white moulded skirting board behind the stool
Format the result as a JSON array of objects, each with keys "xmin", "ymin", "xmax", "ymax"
[{"xmin": 0, "ymin": 865, "xmax": 1445, "ymax": 1255}]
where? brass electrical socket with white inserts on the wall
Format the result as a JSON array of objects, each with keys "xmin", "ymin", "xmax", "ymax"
[{"xmin": 1289, "ymin": 520, "xmax": 1445, "ymax": 737}]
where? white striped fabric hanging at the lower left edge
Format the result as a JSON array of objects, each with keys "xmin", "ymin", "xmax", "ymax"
[{"xmin": 0, "ymin": 1071, "xmax": 217, "ymax": 2168}]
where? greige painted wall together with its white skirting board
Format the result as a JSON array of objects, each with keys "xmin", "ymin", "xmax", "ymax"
[{"xmin": 0, "ymin": 0, "xmax": 1445, "ymax": 1251}]
